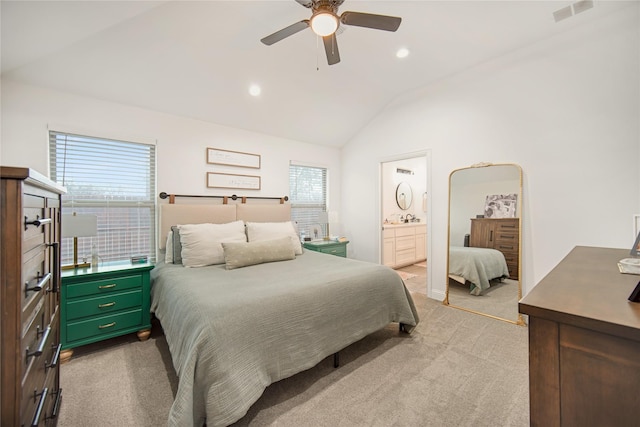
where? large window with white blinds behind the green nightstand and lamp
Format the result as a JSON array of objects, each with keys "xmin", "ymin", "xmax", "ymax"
[{"xmin": 49, "ymin": 131, "xmax": 156, "ymax": 265}]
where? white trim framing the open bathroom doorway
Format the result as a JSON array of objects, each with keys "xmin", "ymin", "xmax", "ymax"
[{"xmin": 377, "ymin": 149, "xmax": 433, "ymax": 298}]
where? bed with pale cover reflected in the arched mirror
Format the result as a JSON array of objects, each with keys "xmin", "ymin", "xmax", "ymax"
[{"xmin": 449, "ymin": 246, "xmax": 509, "ymax": 295}]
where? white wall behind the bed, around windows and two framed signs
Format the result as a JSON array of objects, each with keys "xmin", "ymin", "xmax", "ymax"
[{"xmin": 0, "ymin": 81, "xmax": 341, "ymax": 224}]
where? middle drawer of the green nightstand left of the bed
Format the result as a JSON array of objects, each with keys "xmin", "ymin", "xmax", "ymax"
[{"xmin": 66, "ymin": 289, "xmax": 142, "ymax": 321}]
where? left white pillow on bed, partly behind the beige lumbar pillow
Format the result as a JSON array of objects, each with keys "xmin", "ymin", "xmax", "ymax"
[{"xmin": 178, "ymin": 221, "xmax": 247, "ymax": 267}]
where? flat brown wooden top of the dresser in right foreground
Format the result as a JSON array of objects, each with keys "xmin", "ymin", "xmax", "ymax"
[{"xmin": 518, "ymin": 246, "xmax": 640, "ymax": 341}]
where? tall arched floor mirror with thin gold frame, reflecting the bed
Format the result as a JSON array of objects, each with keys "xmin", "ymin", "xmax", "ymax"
[{"xmin": 443, "ymin": 163, "xmax": 525, "ymax": 325}]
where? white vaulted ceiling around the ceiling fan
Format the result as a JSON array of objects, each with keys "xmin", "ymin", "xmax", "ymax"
[{"xmin": 1, "ymin": 0, "xmax": 632, "ymax": 146}]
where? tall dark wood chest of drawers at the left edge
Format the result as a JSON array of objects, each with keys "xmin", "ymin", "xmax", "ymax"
[{"xmin": 0, "ymin": 166, "xmax": 64, "ymax": 426}]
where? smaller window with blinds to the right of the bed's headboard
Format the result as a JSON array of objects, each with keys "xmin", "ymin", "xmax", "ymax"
[{"xmin": 289, "ymin": 164, "xmax": 327, "ymax": 237}]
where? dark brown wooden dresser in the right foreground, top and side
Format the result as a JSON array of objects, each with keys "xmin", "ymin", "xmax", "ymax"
[{"xmin": 519, "ymin": 246, "xmax": 640, "ymax": 427}]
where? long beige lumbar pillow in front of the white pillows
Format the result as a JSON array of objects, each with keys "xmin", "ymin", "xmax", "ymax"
[{"xmin": 222, "ymin": 236, "xmax": 296, "ymax": 270}]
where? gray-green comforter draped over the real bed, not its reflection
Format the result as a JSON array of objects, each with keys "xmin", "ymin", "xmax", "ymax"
[{"xmin": 151, "ymin": 251, "xmax": 418, "ymax": 426}]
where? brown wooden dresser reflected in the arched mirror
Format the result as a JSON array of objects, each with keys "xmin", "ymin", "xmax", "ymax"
[{"xmin": 469, "ymin": 218, "xmax": 520, "ymax": 280}]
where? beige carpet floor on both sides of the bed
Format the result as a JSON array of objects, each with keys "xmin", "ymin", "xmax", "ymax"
[{"xmin": 59, "ymin": 293, "xmax": 529, "ymax": 427}]
